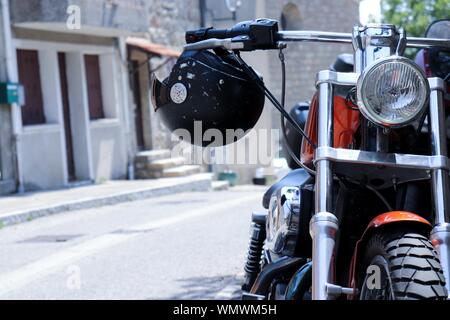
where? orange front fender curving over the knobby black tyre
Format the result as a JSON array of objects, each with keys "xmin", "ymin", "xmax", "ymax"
[{"xmin": 349, "ymin": 211, "xmax": 432, "ymax": 299}]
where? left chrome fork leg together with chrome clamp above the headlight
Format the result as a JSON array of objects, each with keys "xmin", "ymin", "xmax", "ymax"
[{"xmin": 310, "ymin": 25, "xmax": 424, "ymax": 300}]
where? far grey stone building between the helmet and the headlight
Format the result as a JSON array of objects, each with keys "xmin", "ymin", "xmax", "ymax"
[{"xmin": 202, "ymin": 0, "xmax": 359, "ymax": 183}]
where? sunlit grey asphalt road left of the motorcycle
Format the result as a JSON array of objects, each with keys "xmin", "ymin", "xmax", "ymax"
[{"xmin": 0, "ymin": 187, "xmax": 264, "ymax": 299}]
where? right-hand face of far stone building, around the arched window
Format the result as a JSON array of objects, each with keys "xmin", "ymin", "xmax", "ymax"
[{"xmin": 264, "ymin": 0, "xmax": 359, "ymax": 125}]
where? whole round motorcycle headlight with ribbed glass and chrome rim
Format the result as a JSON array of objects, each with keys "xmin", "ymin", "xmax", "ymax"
[{"xmin": 357, "ymin": 57, "xmax": 430, "ymax": 127}]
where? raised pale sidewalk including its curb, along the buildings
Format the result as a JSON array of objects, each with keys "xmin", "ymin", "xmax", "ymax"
[{"xmin": 0, "ymin": 173, "xmax": 212, "ymax": 228}]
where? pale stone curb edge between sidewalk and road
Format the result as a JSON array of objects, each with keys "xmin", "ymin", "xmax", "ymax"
[{"xmin": 0, "ymin": 174, "xmax": 212, "ymax": 229}]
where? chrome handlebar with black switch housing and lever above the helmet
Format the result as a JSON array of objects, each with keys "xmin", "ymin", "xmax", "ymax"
[{"xmin": 185, "ymin": 19, "xmax": 450, "ymax": 51}]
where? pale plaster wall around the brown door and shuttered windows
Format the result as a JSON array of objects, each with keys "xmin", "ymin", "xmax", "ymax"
[{"xmin": 14, "ymin": 39, "xmax": 127, "ymax": 190}]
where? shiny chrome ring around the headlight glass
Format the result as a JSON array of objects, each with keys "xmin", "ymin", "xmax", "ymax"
[{"xmin": 356, "ymin": 56, "xmax": 430, "ymax": 128}]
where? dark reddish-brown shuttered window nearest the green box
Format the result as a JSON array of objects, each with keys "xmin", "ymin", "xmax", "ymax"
[{"xmin": 17, "ymin": 50, "xmax": 45, "ymax": 125}]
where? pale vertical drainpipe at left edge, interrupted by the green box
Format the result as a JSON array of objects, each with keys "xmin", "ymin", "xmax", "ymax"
[{"xmin": 0, "ymin": 0, "xmax": 25, "ymax": 193}]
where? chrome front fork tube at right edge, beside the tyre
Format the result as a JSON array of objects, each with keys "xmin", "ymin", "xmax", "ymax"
[{"xmin": 429, "ymin": 78, "xmax": 450, "ymax": 293}]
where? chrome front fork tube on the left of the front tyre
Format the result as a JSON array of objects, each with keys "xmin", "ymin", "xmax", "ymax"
[{"xmin": 310, "ymin": 82, "xmax": 339, "ymax": 300}]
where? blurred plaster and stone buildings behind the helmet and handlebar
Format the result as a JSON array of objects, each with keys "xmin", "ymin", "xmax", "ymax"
[{"xmin": 0, "ymin": 0, "xmax": 359, "ymax": 194}]
